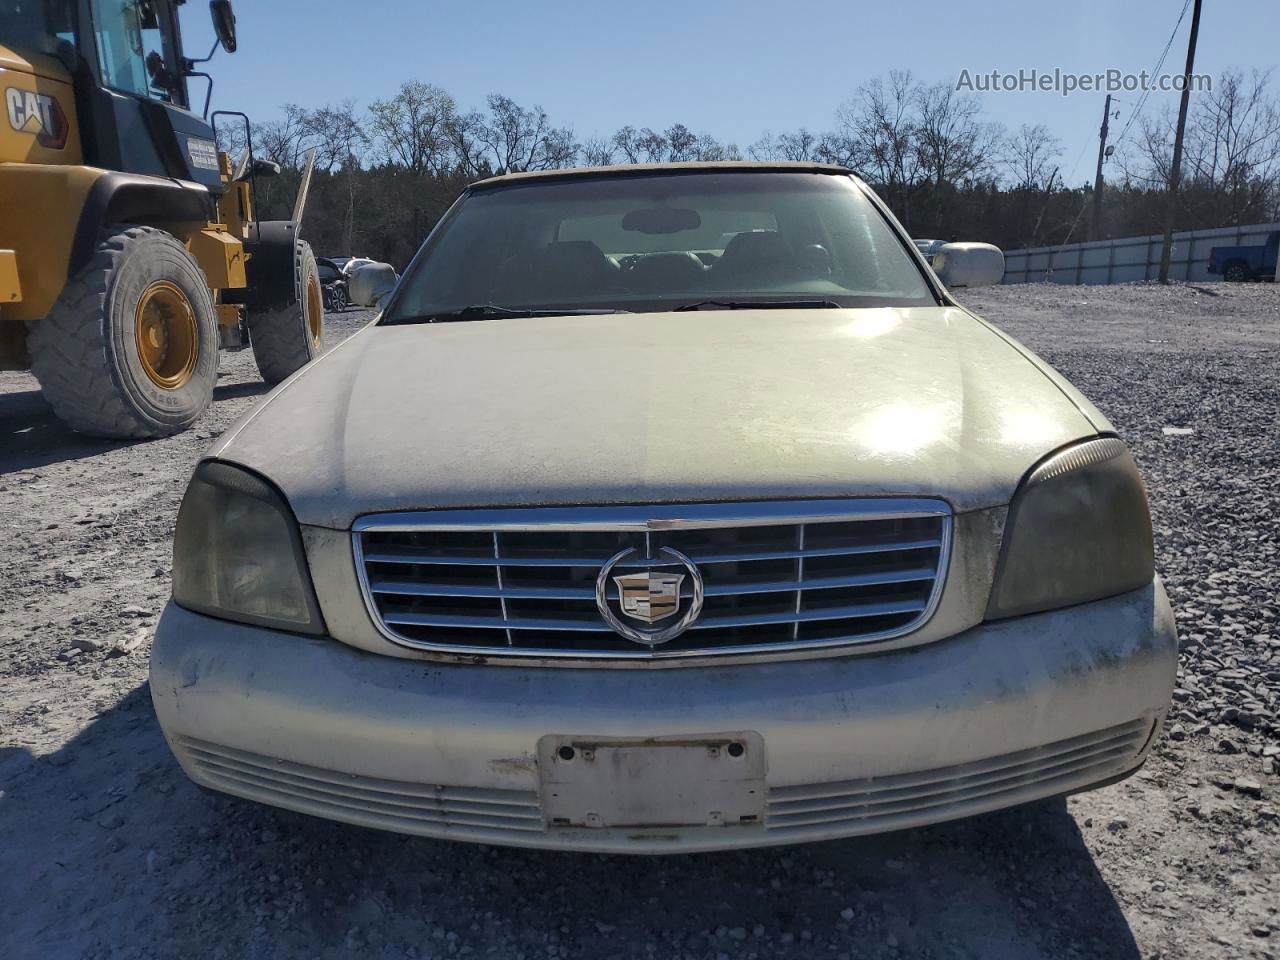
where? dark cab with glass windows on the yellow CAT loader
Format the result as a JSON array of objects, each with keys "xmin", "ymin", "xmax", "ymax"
[{"xmin": 0, "ymin": 0, "xmax": 234, "ymax": 192}]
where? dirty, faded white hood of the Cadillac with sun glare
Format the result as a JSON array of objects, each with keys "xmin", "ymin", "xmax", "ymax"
[{"xmin": 212, "ymin": 307, "xmax": 1108, "ymax": 529}]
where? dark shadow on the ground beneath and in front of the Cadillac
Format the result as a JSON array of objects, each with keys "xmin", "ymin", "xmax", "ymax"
[{"xmin": 0, "ymin": 686, "xmax": 1139, "ymax": 960}]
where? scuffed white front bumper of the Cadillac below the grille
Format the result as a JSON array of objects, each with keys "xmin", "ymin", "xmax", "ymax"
[{"xmin": 151, "ymin": 580, "xmax": 1178, "ymax": 854}]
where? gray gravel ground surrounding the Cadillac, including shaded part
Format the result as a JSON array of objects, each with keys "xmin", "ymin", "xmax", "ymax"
[{"xmin": 0, "ymin": 284, "xmax": 1280, "ymax": 960}]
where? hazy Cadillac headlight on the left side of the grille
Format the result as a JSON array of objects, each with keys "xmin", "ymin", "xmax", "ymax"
[{"xmin": 173, "ymin": 461, "xmax": 324, "ymax": 634}]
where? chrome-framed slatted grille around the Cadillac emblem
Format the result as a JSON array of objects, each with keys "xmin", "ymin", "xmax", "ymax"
[{"xmin": 353, "ymin": 499, "xmax": 951, "ymax": 659}]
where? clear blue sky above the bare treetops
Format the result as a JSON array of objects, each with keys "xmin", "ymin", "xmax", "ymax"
[{"xmin": 183, "ymin": 0, "xmax": 1280, "ymax": 183}]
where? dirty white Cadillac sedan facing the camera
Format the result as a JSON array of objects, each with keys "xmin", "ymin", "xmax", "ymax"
[{"xmin": 151, "ymin": 164, "xmax": 1176, "ymax": 854}]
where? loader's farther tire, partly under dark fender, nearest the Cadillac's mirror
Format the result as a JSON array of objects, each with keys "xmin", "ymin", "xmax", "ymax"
[{"xmin": 248, "ymin": 241, "xmax": 324, "ymax": 387}]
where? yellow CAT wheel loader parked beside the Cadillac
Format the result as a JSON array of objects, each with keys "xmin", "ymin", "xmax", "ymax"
[{"xmin": 0, "ymin": 0, "xmax": 324, "ymax": 439}]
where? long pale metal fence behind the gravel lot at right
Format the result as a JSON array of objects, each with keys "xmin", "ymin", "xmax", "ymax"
[{"xmin": 1004, "ymin": 223, "xmax": 1280, "ymax": 284}]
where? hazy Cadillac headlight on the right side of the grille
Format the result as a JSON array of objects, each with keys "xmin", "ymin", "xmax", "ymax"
[{"xmin": 987, "ymin": 436, "xmax": 1155, "ymax": 620}]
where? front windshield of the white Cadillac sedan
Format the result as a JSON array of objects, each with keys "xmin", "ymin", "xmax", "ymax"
[{"xmin": 387, "ymin": 172, "xmax": 937, "ymax": 323}]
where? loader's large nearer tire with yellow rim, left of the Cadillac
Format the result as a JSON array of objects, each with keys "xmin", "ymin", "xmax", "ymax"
[{"xmin": 27, "ymin": 224, "xmax": 218, "ymax": 439}]
